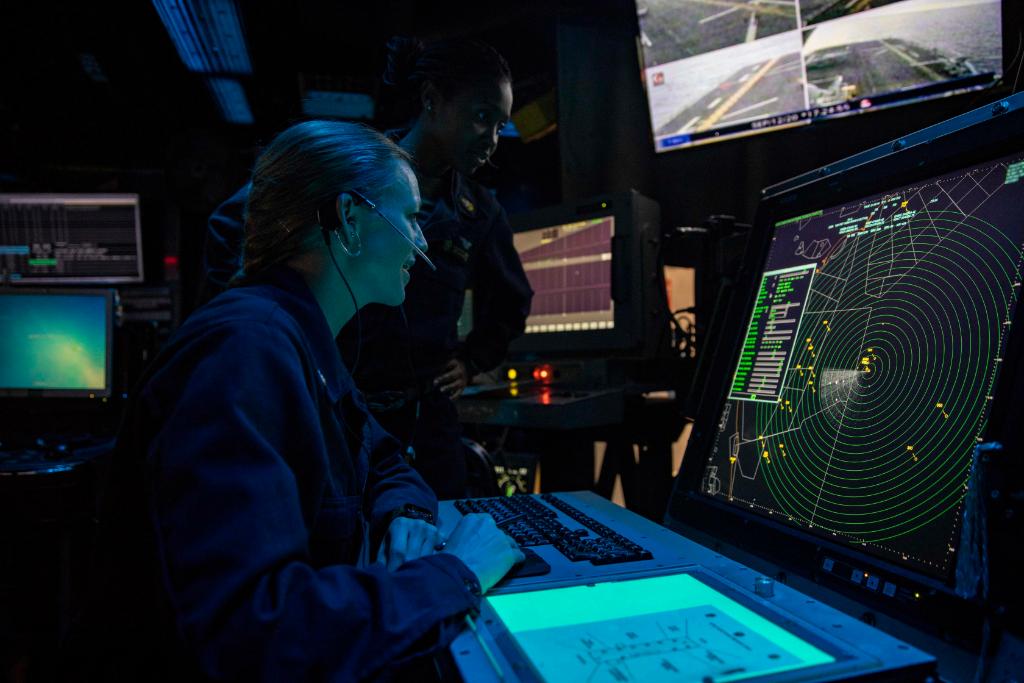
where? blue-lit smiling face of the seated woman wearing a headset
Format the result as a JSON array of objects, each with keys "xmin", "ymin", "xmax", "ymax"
[{"xmin": 356, "ymin": 162, "xmax": 427, "ymax": 306}]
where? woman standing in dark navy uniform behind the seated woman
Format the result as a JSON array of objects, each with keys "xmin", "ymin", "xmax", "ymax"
[{"xmin": 206, "ymin": 38, "xmax": 532, "ymax": 499}]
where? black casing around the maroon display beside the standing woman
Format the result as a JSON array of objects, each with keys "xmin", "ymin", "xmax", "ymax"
[{"xmin": 509, "ymin": 189, "xmax": 668, "ymax": 358}]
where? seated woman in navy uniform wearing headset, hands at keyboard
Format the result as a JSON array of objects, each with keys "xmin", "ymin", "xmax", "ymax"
[{"xmin": 77, "ymin": 122, "xmax": 522, "ymax": 681}]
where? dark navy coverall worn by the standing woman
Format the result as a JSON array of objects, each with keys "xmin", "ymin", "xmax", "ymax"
[{"xmin": 205, "ymin": 170, "xmax": 534, "ymax": 500}]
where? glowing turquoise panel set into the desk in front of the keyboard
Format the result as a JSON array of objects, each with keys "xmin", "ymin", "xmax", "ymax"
[{"xmin": 487, "ymin": 573, "xmax": 837, "ymax": 683}]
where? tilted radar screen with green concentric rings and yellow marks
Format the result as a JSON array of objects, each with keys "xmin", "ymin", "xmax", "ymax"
[{"xmin": 700, "ymin": 154, "xmax": 1024, "ymax": 577}]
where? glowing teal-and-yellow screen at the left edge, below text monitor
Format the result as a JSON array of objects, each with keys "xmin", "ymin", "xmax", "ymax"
[{"xmin": 0, "ymin": 288, "xmax": 113, "ymax": 397}]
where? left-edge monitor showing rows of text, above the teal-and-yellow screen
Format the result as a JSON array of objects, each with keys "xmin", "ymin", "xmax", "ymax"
[{"xmin": 0, "ymin": 194, "xmax": 143, "ymax": 285}]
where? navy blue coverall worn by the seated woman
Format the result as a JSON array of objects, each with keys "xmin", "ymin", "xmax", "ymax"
[{"xmin": 79, "ymin": 266, "xmax": 479, "ymax": 681}]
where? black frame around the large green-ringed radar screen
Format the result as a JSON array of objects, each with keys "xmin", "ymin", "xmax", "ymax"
[{"xmin": 666, "ymin": 94, "xmax": 1024, "ymax": 599}]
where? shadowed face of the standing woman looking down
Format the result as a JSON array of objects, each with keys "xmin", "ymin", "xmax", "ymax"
[{"xmin": 434, "ymin": 79, "xmax": 512, "ymax": 175}]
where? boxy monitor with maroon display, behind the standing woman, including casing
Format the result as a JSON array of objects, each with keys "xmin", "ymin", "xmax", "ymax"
[{"xmin": 510, "ymin": 191, "xmax": 664, "ymax": 354}]
